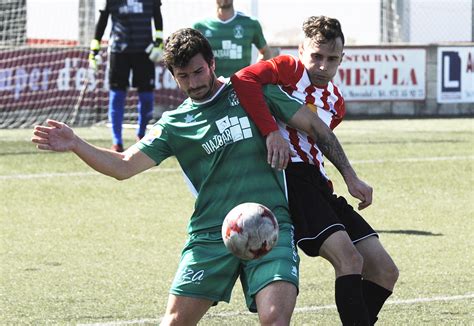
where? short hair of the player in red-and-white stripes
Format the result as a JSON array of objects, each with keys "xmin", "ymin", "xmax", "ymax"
[{"xmin": 303, "ymin": 16, "xmax": 345, "ymax": 45}]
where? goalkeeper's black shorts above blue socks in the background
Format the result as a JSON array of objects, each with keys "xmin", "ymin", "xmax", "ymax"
[{"xmin": 109, "ymin": 52, "xmax": 155, "ymax": 92}]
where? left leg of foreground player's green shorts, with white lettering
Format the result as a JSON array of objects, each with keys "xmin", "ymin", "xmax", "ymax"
[{"xmin": 170, "ymin": 232, "xmax": 240, "ymax": 303}]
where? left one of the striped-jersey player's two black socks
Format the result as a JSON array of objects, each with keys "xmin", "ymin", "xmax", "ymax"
[{"xmin": 336, "ymin": 274, "xmax": 369, "ymax": 326}]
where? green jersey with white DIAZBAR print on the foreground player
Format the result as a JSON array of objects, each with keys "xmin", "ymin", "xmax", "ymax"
[{"xmin": 138, "ymin": 82, "xmax": 301, "ymax": 233}]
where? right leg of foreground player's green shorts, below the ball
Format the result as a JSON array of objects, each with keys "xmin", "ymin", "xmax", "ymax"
[{"xmin": 240, "ymin": 224, "xmax": 300, "ymax": 312}]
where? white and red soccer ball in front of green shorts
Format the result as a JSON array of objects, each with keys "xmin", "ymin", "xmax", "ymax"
[{"xmin": 222, "ymin": 203, "xmax": 279, "ymax": 260}]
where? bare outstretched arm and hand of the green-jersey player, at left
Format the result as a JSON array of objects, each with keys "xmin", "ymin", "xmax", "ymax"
[{"xmin": 31, "ymin": 120, "xmax": 155, "ymax": 180}]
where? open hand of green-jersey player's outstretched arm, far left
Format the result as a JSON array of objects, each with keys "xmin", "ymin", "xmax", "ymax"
[{"xmin": 31, "ymin": 119, "xmax": 76, "ymax": 152}]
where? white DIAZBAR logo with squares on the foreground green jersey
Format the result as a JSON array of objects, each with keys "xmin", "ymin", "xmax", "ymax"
[{"xmin": 202, "ymin": 116, "xmax": 253, "ymax": 154}]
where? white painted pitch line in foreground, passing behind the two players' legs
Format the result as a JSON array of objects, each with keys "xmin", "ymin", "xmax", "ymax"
[{"xmin": 78, "ymin": 293, "xmax": 474, "ymax": 326}]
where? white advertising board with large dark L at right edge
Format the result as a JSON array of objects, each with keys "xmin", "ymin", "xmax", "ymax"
[{"xmin": 436, "ymin": 46, "xmax": 474, "ymax": 103}]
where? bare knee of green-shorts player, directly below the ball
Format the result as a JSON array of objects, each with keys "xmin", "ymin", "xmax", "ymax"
[{"xmin": 255, "ymin": 281, "xmax": 298, "ymax": 325}]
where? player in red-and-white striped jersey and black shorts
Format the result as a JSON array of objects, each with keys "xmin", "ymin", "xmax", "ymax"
[{"xmin": 231, "ymin": 16, "xmax": 398, "ymax": 325}]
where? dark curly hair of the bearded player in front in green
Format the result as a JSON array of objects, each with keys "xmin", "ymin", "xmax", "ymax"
[{"xmin": 163, "ymin": 28, "xmax": 214, "ymax": 75}]
